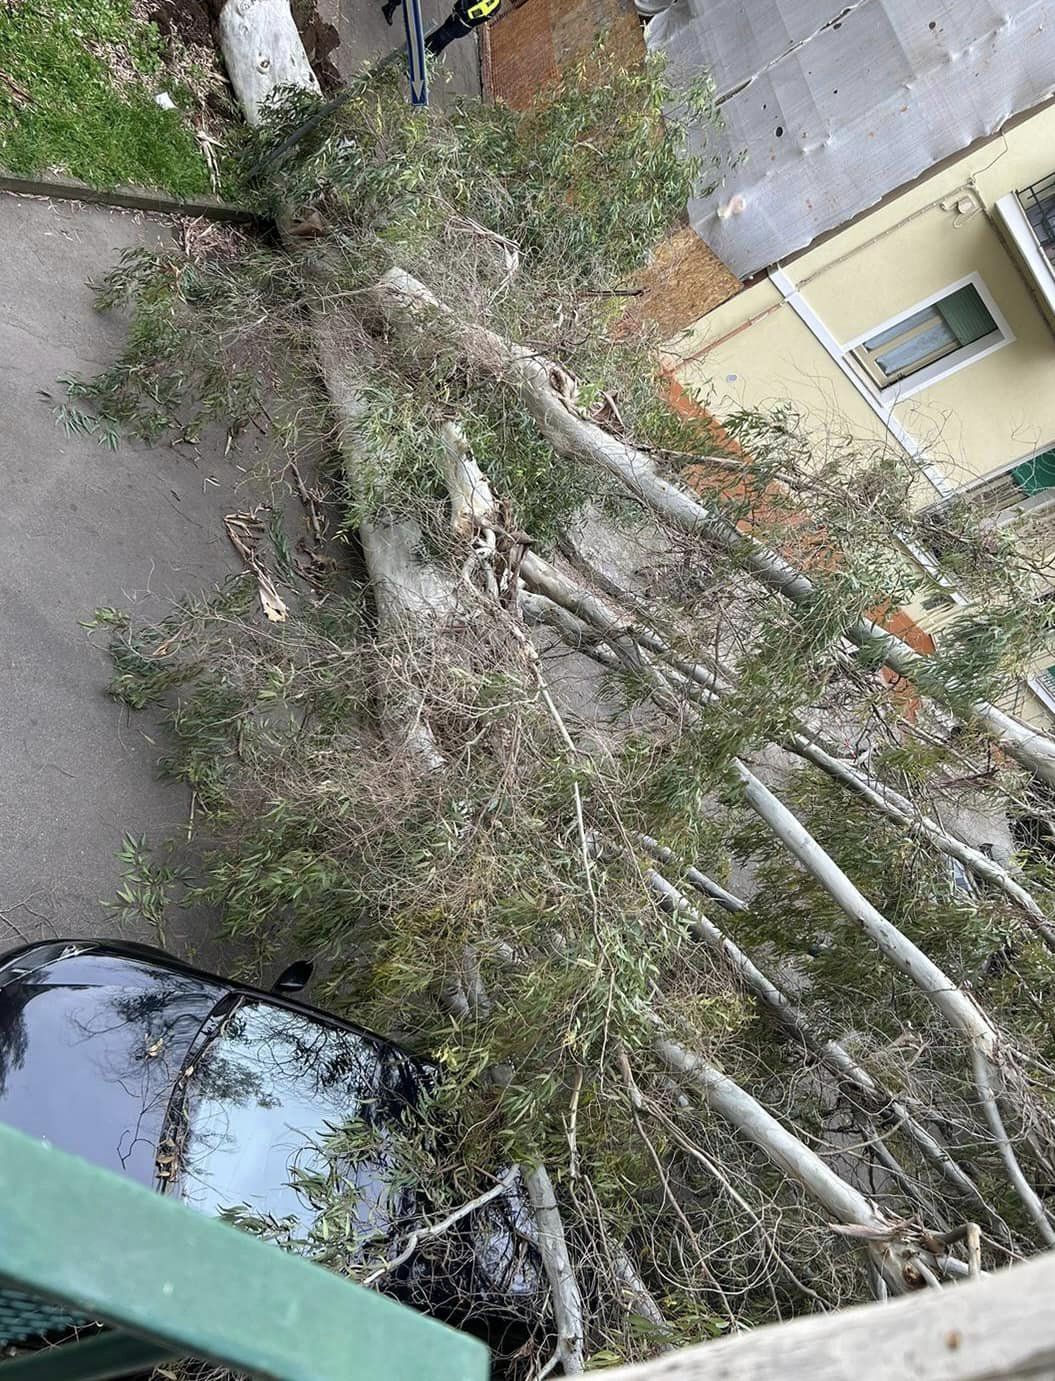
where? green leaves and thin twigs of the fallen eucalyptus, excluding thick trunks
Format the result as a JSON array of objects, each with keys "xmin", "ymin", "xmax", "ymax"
[{"xmin": 73, "ymin": 45, "xmax": 1055, "ymax": 1374}]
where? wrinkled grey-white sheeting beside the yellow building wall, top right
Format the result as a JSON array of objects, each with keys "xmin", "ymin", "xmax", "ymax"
[{"xmin": 645, "ymin": 0, "xmax": 1055, "ymax": 278}]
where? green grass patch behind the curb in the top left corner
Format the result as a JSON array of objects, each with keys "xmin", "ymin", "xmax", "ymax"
[{"xmin": 0, "ymin": 0, "xmax": 238, "ymax": 196}]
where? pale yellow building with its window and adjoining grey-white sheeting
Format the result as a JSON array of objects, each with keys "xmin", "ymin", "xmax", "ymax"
[{"xmin": 646, "ymin": 0, "xmax": 1055, "ymax": 722}]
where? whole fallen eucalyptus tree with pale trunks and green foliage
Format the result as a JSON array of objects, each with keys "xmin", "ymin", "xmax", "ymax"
[{"xmin": 76, "ymin": 8, "xmax": 1055, "ymax": 1374}]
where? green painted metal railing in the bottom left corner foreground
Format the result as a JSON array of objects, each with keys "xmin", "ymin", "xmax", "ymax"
[{"xmin": 0, "ymin": 1124, "xmax": 489, "ymax": 1381}]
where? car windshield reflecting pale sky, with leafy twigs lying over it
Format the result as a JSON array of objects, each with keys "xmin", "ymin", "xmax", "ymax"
[{"xmin": 167, "ymin": 1000, "xmax": 421, "ymax": 1240}]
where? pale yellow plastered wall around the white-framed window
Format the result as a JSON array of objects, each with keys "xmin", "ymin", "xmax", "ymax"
[{"xmin": 668, "ymin": 105, "xmax": 1055, "ymax": 501}]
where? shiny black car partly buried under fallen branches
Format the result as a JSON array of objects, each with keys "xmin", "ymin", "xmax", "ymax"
[{"xmin": 0, "ymin": 940, "xmax": 541, "ymax": 1351}]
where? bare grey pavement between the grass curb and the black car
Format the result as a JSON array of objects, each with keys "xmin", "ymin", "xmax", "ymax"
[{"xmin": 0, "ymin": 195, "xmax": 250, "ymax": 954}]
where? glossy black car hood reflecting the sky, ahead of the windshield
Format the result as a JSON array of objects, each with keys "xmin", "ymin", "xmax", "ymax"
[{"xmin": 0, "ymin": 945, "xmax": 229, "ymax": 1186}]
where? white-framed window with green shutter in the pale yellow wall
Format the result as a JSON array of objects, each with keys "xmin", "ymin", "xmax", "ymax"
[{"xmin": 852, "ymin": 283, "xmax": 1007, "ymax": 388}]
